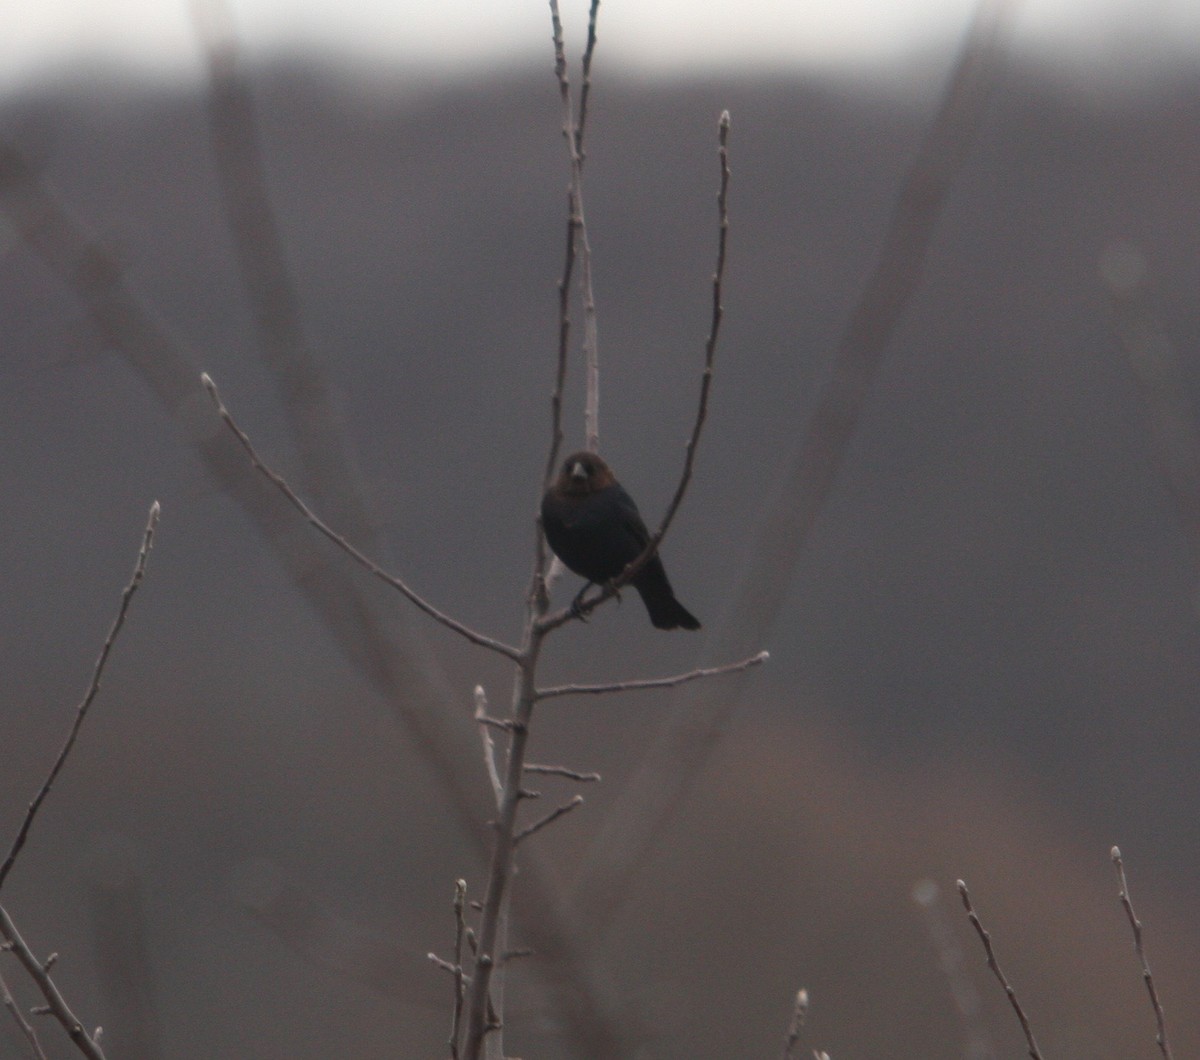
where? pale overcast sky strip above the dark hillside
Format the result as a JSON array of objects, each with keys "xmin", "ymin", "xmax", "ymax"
[{"xmin": 0, "ymin": 0, "xmax": 1200, "ymax": 89}]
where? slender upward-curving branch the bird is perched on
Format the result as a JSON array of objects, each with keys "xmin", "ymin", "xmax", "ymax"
[{"xmin": 538, "ymin": 111, "xmax": 731, "ymax": 631}]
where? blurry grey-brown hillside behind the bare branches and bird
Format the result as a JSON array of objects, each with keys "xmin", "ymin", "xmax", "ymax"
[{"xmin": 0, "ymin": 55, "xmax": 1200, "ymax": 1060}]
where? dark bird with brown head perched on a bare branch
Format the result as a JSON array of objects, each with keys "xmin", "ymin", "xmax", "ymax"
[{"xmin": 541, "ymin": 453, "xmax": 700, "ymax": 629}]
